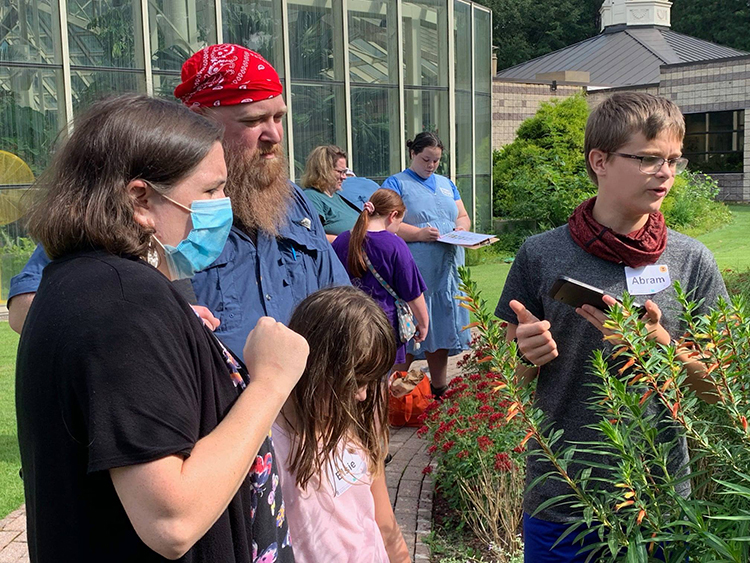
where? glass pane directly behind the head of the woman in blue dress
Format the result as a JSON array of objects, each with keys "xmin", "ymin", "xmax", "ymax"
[{"xmin": 404, "ymin": 89, "xmax": 450, "ymax": 176}]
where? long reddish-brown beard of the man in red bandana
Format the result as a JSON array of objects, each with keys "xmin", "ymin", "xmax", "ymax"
[{"xmin": 224, "ymin": 144, "xmax": 293, "ymax": 237}]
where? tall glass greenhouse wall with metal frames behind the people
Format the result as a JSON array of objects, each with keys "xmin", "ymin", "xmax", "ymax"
[{"xmin": 0, "ymin": 0, "xmax": 492, "ymax": 229}]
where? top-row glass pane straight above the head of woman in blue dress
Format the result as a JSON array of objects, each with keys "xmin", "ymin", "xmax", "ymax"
[{"xmin": 402, "ymin": 0, "xmax": 448, "ymax": 86}]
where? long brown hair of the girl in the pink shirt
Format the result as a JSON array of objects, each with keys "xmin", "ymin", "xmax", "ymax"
[{"xmin": 285, "ymin": 286, "xmax": 396, "ymax": 489}]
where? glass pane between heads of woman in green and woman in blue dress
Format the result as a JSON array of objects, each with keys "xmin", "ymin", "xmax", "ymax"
[{"xmin": 352, "ymin": 88, "xmax": 401, "ymax": 183}]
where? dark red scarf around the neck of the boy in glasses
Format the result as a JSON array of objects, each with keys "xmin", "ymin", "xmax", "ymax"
[{"xmin": 568, "ymin": 197, "xmax": 667, "ymax": 268}]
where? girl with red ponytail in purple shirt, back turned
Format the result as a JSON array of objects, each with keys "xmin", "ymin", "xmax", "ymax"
[{"xmin": 333, "ymin": 188, "xmax": 429, "ymax": 364}]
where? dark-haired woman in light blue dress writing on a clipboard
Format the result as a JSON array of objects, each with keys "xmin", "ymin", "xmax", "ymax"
[{"xmin": 383, "ymin": 132, "xmax": 471, "ymax": 397}]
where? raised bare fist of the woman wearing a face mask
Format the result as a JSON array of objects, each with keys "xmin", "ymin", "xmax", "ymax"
[{"xmin": 242, "ymin": 317, "xmax": 310, "ymax": 397}]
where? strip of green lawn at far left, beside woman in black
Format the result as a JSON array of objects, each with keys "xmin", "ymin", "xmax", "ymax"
[{"xmin": 0, "ymin": 323, "xmax": 23, "ymax": 518}]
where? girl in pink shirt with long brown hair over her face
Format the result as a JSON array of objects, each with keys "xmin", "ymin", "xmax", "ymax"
[{"xmin": 273, "ymin": 286, "xmax": 410, "ymax": 563}]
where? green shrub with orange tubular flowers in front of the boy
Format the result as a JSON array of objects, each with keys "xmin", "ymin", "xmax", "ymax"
[{"xmin": 461, "ymin": 269, "xmax": 750, "ymax": 563}]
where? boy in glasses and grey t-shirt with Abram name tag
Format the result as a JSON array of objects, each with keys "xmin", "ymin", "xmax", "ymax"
[{"xmin": 495, "ymin": 92, "xmax": 727, "ymax": 563}]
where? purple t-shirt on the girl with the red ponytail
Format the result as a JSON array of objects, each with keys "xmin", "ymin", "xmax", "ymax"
[{"xmin": 333, "ymin": 231, "xmax": 427, "ymax": 364}]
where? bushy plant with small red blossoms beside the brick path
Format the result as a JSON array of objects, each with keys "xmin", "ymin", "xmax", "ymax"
[{"xmin": 424, "ymin": 290, "xmax": 527, "ymax": 561}]
